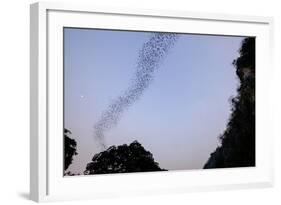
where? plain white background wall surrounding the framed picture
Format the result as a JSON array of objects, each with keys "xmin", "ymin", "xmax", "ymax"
[{"xmin": 0, "ymin": 0, "xmax": 281, "ymax": 205}]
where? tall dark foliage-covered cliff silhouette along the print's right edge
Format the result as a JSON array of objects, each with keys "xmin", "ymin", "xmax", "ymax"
[{"xmin": 204, "ymin": 38, "xmax": 255, "ymax": 168}]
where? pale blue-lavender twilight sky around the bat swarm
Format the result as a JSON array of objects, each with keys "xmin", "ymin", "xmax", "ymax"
[{"xmin": 64, "ymin": 28, "xmax": 243, "ymax": 174}]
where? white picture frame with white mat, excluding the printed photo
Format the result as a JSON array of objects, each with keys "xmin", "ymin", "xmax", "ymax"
[{"xmin": 30, "ymin": 2, "xmax": 273, "ymax": 202}]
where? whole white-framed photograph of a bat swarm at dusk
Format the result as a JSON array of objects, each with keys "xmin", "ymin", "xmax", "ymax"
[{"xmin": 30, "ymin": 3, "xmax": 273, "ymax": 201}]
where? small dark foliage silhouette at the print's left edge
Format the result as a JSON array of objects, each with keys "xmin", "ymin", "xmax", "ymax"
[{"xmin": 64, "ymin": 129, "xmax": 78, "ymax": 174}]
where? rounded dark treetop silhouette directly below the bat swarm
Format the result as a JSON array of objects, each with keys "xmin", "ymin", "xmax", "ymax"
[{"xmin": 84, "ymin": 141, "xmax": 165, "ymax": 174}]
